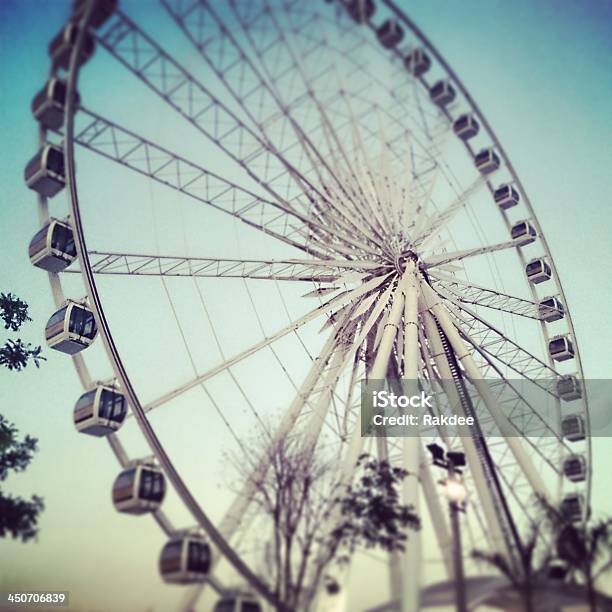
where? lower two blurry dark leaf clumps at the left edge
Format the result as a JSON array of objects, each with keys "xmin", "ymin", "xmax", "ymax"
[{"xmin": 0, "ymin": 415, "xmax": 44, "ymax": 542}]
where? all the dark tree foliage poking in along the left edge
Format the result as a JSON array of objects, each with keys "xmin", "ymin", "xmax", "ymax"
[{"xmin": 0, "ymin": 293, "xmax": 45, "ymax": 542}]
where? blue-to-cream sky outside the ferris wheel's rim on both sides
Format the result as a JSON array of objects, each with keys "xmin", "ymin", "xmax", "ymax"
[{"xmin": 0, "ymin": 0, "xmax": 612, "ymax": 610}]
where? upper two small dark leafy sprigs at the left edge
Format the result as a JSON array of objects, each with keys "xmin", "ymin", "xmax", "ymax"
[{"xmin": 0, "ymin": 293, "xmax": 45, "ymax": 372}]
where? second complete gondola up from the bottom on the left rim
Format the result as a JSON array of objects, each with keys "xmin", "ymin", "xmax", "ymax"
[{"xmin": 113, "ymin": 462, "xmax": 166, "ymax": 514}]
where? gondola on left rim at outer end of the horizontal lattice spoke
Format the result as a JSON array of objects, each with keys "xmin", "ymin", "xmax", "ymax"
[{"xmin": 28, "ymin": 219, "xmax": 77, "ymax": 272}]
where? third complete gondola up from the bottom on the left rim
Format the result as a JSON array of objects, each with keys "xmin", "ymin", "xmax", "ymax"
[{"xmin": 73, "ymin": 384, "xmax": 127, "ymax": 436}]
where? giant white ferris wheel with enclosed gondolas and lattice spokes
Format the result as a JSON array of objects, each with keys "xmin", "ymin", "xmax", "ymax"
[{"xmin": 25, "ymin": 0, "xmax": 591, "ymax": 612}]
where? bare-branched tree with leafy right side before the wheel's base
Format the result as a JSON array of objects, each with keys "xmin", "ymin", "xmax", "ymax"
[{"xmin": 241, "ymin": 436, "xmax": 419, "ymax": 610}]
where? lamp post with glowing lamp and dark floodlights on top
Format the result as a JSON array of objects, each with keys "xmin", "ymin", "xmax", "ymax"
[{"xmin": 427, "ymin": 444, "xmax": 468, "ymax": 612}]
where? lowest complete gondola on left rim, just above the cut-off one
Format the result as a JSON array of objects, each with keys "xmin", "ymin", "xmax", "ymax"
[{"xmin": 159, "ymin": 535, "xmax": 212, "ymax": 584}]
